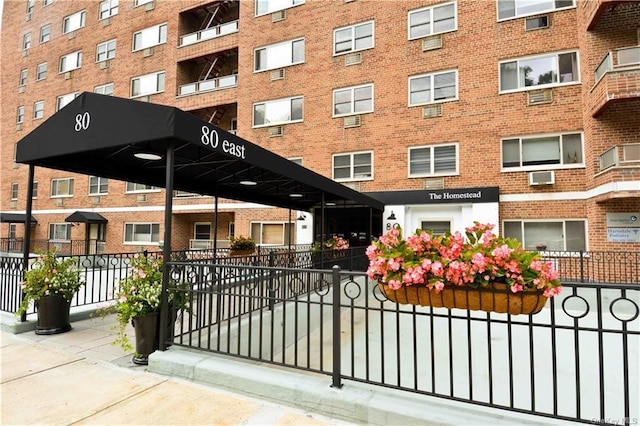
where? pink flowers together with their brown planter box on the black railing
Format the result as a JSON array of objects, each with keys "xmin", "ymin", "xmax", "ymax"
[{"xmin": 367, "ymin": 222, "xmax": 562, "ymax": 315}]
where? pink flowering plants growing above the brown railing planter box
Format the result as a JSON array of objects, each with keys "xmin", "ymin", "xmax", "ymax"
[{"xmin": 367, "ymin": 222, "xmax": 562, "ymax": 297}]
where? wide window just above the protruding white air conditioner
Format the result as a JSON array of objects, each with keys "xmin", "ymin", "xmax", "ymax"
[{"xmin": 502, "ymin": 133, "xmax": 584, "ymax": 170}]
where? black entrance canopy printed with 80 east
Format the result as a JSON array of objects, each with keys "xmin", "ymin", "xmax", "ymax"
[{"xmin": 16, "ymin": 92, "xmax": 384, "ymax": 211}]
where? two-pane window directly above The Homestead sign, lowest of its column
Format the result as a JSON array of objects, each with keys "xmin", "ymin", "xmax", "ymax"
[{"xmin": 409, "ymin": 144, "xmax": 458, "ymax": 177}]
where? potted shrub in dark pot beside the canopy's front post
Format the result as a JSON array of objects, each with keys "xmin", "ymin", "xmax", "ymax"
[{"xmin": 102, "ymin": 254, "xmax": 187, "ymax": 365}]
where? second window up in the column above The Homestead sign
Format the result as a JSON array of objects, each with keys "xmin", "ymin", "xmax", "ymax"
[{"xmin": 409, "ymin": 70, "xmax": 458, "ymax": 106}]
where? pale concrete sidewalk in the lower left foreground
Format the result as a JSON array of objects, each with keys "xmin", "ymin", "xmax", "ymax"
[{"xmin": 0, "ymin": 317, "xmax": 356, "ymax": 425}]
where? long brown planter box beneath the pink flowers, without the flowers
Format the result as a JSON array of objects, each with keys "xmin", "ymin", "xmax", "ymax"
[{"xmin": 378, "ymin": 282, "xmax": 548, "ymax": 315}]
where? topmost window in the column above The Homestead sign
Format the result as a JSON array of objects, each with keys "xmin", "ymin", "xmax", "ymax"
[{"xmin": 409, "ymin": 2, "xmax": 458, "ymax": 40}]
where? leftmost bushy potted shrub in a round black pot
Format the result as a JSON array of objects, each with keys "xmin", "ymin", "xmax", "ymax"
[{"xmin": 16, "ymin": 248, "xmax": 85, "ymax": 334}]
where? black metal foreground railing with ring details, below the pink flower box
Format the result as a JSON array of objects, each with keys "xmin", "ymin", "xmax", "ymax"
[{"xmin": 167, "ymin": 263, "xmax": 640, "ymax": 424}]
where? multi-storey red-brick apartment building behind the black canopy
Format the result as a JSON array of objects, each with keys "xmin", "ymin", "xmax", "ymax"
[{"xmin": 0, "ymin": 0, "xmax": 640, "ymax": 252}]
